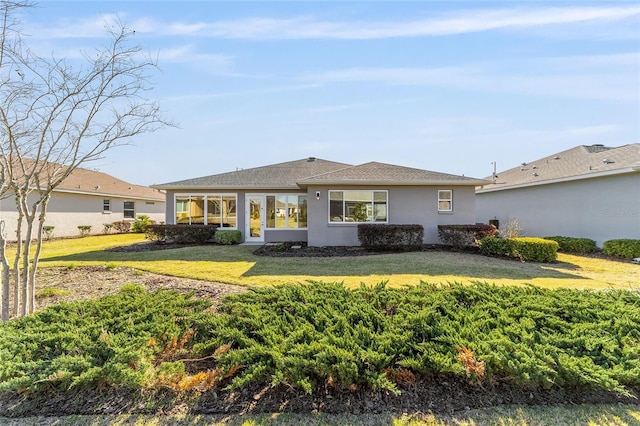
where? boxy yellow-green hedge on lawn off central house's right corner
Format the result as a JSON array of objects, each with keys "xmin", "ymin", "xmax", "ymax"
[{"xmin": 480, "ymin": 237, "xmax": 558, "ymax": 262}]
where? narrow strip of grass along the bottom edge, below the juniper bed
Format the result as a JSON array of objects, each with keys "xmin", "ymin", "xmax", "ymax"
[{"xmin": 0, "ymin": 405, "xmax": 640, "ymax": 426}]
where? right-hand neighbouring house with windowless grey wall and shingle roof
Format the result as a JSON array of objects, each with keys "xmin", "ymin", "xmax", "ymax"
[{"xmin": 476, "ymin": 143, "xmax": 640, "ymax": 246}]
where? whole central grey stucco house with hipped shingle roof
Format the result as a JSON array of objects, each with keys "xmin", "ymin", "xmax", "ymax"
[{"xmin": 153, "ymin": 157, "xmax": 489, "ymax": 247}]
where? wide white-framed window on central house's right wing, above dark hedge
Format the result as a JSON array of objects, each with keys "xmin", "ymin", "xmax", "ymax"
[{"xmin": 329, "ymin": 190, "xmax": 388, "ymax": 223}]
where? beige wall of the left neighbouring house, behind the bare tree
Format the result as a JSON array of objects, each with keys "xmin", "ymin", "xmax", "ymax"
[{"xmin": 0, "ymin": 192, "xmax": 165, "ymax": 240}]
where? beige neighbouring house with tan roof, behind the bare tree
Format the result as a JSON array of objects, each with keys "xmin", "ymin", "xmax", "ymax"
[{"xmin": 0, "ymin": 169, "xmax": 165, "ymax": 240}]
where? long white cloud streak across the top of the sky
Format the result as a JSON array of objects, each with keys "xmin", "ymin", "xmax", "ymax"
[{"xmin": 25, "ymin": 5, "xmax": 640, "ymax": 40}]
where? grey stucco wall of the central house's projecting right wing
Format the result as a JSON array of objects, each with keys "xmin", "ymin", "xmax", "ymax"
[{"xmin": 308, "ymin": 186, "xmax": 476, "ymax": 246}]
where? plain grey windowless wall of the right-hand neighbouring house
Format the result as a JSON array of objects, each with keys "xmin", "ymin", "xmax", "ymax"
[{"xmin": 476, "ymin": 173, "xmax": 640, "ymax": 247}]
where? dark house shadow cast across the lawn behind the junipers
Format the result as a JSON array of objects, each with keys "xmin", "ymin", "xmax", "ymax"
[{"xmin": 42, "ymin": 246, "xmax": 586, "ymax": 280}]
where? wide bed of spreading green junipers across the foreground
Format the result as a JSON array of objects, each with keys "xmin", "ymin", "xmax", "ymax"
[{"xmin": 0, "ymin": 280, "xmax": 640, "ymax": 416}]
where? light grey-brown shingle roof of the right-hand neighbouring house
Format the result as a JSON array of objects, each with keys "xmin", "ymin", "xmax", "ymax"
[{"xmin": 477, "ymin": 143, "xmax": 640, "ymax": 193}]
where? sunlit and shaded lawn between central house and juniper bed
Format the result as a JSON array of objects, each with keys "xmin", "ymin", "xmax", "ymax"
[{"xmin": 32, "ymin": 234, "xmax": 640, "ymax": 289}]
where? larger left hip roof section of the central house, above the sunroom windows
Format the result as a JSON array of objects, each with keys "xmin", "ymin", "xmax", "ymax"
[{"xmin": 153, "ymin": 157, "xmax": 350, "ymax": 190}]
